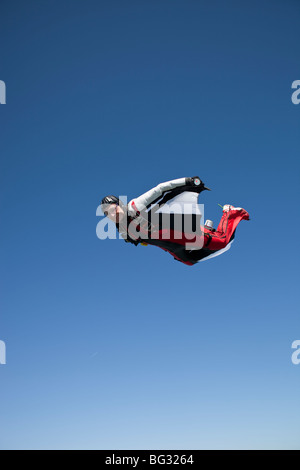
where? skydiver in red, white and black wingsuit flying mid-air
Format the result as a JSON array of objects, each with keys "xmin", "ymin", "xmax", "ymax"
[{"xmin": 101, "ymin": 176, "xmax": 249, "ymax": 266}]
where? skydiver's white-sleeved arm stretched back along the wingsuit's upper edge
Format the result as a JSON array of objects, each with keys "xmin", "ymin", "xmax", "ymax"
[{"xmin": 128, "ymin": 178, "xmax": 193, "ymax": 213}]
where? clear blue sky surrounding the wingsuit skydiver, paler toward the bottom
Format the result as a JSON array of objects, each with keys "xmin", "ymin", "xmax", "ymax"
[{"xmin": 0, "ymin": 0, "xmax": 300, "ymax": 449}]
